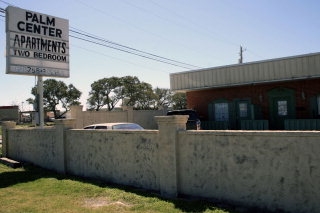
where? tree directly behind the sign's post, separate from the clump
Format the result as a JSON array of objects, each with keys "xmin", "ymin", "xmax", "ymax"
[{"xmin": 27, "ymin": 79, "xmax": 81, "ymax": 118}]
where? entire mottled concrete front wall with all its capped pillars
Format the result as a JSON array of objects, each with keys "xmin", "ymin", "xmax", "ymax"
[{"xmin": 2, "ymin": 119, "xmax": 320, "ymax": 213}]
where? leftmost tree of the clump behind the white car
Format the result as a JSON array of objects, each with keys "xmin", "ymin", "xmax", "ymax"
[{"xmin": 87, "ymin": 77, "xmax": 122, "ymax": 111}]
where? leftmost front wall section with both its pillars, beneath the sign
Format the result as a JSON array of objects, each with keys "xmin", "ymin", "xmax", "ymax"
[{"xmin": 2, "ymin": 119, "xmax": 75, "ymax": 173}]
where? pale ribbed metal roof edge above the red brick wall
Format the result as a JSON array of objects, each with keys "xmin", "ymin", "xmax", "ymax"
[{"xmin": 170, "ymin": 53, "xmax": 320, "ymax": 91}]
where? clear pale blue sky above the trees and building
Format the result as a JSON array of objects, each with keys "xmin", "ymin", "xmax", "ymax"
[{"xmin": 0, "ymin": 0, "xmax": 320, "ymax": 110}]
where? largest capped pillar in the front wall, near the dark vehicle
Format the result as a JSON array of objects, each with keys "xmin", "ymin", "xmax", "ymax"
[{"xmin": 155, "ymin": 115, "xmax": 189, "ymax": 198}]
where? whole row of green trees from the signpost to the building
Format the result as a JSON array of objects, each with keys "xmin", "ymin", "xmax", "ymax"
[{"xmin": 27, "ymin": 76, "xmax": 186, "ymax": 113}]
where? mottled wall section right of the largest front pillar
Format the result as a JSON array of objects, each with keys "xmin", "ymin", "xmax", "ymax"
[{"xmin": 177, "ymin": 131, "xmax": 320, "ymax": 212}]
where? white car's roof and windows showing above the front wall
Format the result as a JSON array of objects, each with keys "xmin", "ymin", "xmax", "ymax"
[{"xmin": 84, "ymin": 122, "xmax": 143, "ymax": 130}]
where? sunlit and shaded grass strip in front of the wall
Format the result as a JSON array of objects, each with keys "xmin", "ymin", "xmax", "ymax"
[{"xmin": 0, "ymin": 164, "xmax": 250, "ymax": 213}]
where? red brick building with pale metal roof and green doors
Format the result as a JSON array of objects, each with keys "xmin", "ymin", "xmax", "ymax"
[{"xmin": 170, "ymin": 53, "xmax": 320, "ymax": 130}]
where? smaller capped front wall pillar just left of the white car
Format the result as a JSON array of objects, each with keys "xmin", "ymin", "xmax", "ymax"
[{"xmin": 54, "ymin": 119, "xmax": 76, "ymax": 174}]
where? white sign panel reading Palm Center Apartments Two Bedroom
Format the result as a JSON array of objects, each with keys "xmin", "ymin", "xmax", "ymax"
[{"xmin": 6, "ymin": 6, "xmax": 70, "ymax": 78}]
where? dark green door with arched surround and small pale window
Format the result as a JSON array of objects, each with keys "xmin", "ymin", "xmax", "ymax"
[{"xmin": 268, "ymin": 88, "xmax": 295, "ymax": 130}]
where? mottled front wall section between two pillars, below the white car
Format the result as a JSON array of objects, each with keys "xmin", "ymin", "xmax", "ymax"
[{"xmin": 66, "ymin": 130, "xmax": 159, "ymax": 191}]
